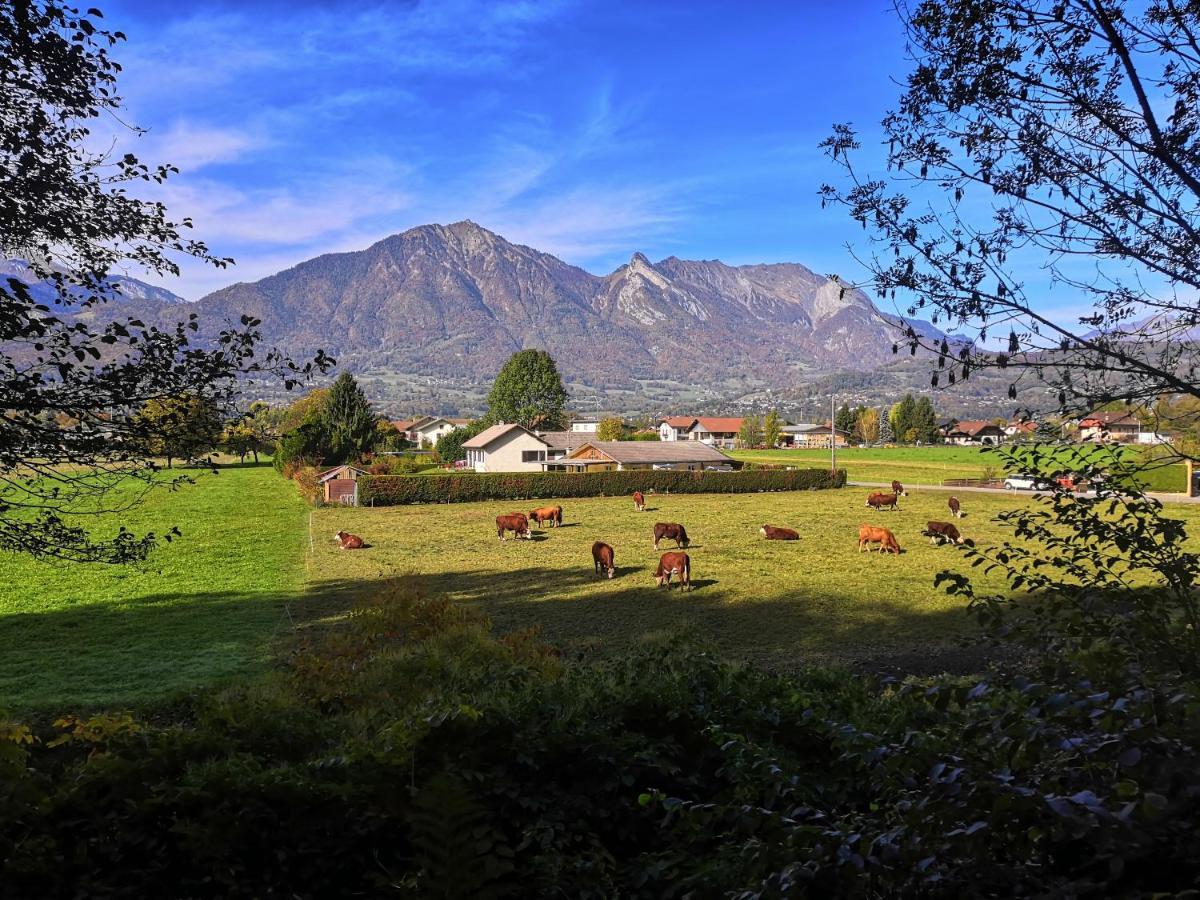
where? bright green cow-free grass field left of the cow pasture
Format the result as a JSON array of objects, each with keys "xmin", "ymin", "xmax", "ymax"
[{"xmin": 0, "ymin": 466, "xmax": 307, "ymax": 709}]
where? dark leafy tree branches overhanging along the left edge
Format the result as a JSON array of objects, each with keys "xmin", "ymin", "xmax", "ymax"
[{"xmin": 0, "ymin": 0, "xmax": 329, "ymax": 563}]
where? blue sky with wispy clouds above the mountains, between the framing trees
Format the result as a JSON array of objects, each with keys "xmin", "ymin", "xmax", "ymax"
[{"xmin": 103, "ymin": 0, "xmax": 905, "ymax": 299}]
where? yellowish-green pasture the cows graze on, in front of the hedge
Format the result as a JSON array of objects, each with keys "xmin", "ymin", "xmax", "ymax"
[{"xmin": 314, "ymin": 488, "xmax": 1070, "ymax": 665}]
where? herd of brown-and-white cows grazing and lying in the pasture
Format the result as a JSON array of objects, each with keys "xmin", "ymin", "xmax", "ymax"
[{"xmin": 334, "ymin": 481, "xmax": 966, "ymax": 590}]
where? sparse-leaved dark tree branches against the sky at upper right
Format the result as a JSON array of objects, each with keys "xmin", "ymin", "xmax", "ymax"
[{"xmin": 822, "ymin": 0, "xmax": 1200, "ymax": 436}]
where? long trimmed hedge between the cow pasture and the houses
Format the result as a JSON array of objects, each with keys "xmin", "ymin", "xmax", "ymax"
[{"xmin": 359, "ymin": 469, "xmax": 846, "ymax": 506}]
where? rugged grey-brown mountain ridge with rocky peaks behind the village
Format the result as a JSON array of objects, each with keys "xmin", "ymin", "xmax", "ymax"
[{"xmin": 180, "ymin": 222, "xmax": 940, "ymax": 389}]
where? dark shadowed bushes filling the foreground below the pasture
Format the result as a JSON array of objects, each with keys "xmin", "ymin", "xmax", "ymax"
[{"xmin": 0, "ymin": 580, "xmax": 1200, "ymax": 898}]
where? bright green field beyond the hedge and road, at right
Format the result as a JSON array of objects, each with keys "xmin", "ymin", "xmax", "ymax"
[{"xmin": 730, "ymin": 445, "xmax": 1186, "ymax": 492}]
